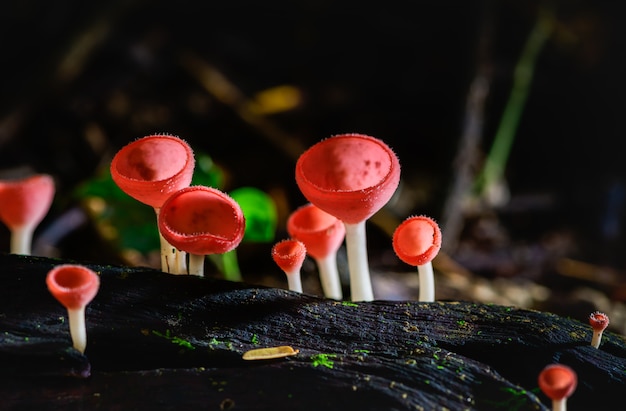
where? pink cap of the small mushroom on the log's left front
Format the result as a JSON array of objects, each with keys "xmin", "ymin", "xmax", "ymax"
[{"xmin": 46, "ymin": 264, "xmax": 100, "ymax": 310}]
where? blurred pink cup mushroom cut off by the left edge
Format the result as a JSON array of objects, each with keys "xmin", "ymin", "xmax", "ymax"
[{"xmin": 0, "ymin": 174, "xmax": 55, "ymax": 255}]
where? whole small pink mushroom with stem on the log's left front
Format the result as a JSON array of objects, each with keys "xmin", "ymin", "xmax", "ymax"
[{"xmin": 46, "ymin": 264, "xmax": 100, "ymax": 353}]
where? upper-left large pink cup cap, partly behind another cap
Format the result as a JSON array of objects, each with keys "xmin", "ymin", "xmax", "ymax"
[{"xmin": 111, "ymin": 134, "xmax": 195, "ymax": 209}]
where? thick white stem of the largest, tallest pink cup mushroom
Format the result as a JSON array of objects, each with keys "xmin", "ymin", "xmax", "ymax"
[{"xmin": 344, "ymin": 221, "xmax": 374, "ymax": 301}]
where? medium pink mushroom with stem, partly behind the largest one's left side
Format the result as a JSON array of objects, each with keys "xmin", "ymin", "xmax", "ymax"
[{"xmin": 287, "ymin": 203, "xmax": 346, "ymax": 300}]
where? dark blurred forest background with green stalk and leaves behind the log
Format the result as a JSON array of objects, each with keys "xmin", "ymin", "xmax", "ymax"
[{"xmin": 0, "ymin": 0, "xmax": 626, "ymax": 332}]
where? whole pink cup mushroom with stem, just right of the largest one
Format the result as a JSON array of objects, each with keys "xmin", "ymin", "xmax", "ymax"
[{"xmin": 392, "ymin": 216, "xmax": 441, "ymax": 302}]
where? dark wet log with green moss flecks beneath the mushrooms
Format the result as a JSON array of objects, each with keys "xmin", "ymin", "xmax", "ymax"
[{"xmin": 0, "ymin": 255, "xmax": 626, "ymax": 410}]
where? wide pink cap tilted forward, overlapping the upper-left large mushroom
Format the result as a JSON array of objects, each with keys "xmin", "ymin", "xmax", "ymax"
[{"xmin": 158, "ymin": 186, "xmax": 246, "ymax": 255}]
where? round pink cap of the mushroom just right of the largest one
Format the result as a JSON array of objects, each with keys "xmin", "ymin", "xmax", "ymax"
[{"xmin": 392, "ymin": 216, "xmax": 441, "ymax": 266}]
